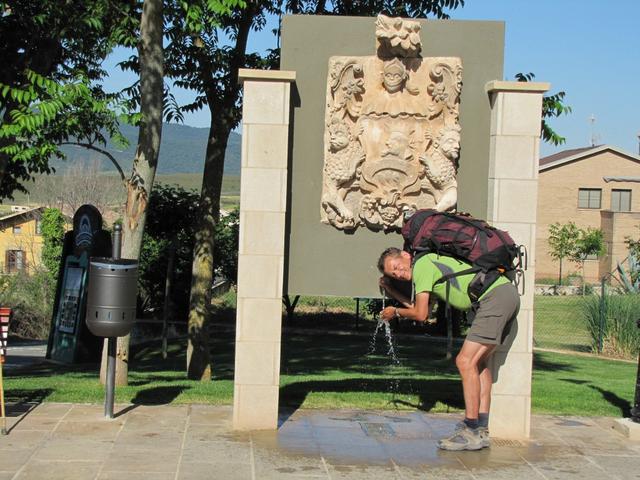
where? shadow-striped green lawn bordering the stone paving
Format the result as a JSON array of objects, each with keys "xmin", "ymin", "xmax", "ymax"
[{"xmin": 5, "ymin": 329, "xmax": 637, "ymax": 417}]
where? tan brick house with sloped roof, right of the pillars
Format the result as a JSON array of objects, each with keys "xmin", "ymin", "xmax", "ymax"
[{"xmin": 536, "ymin": 145, "xmax": 640, "ymax": 282}]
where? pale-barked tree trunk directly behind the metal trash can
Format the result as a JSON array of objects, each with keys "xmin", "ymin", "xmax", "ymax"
[{"xmin": 102, "ymin": 0, "xmax": 164, "ymax": 385}]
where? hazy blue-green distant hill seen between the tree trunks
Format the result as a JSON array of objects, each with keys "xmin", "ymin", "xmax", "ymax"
[{"xmin": 53, "ymin": 123, "xmax": 242, "ymax": 175}]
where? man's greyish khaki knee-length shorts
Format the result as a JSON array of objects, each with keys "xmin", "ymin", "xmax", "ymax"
[{"xmin": 467, "ymin": 283, "xmax": 520, "ymax": 345}]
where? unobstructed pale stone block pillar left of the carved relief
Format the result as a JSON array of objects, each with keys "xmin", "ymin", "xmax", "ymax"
[{"xmin": 233, "ymin": 69, "xmax": 295, "ymax": 430}]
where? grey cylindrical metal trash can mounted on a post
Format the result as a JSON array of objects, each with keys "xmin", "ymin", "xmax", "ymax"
[{"xmin": 86, "ymin": 257, "xmax": 138, "ymax": 337}]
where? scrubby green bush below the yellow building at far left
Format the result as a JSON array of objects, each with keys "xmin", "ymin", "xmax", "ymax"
[{"xmin": 0, "ymin": 269, "xmax": 56, "ymax": 339}]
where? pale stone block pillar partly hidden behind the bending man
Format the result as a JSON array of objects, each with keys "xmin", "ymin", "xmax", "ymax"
[{"xmin": 486, "ymin": 81, "xmax": 550, "ymax": 439}]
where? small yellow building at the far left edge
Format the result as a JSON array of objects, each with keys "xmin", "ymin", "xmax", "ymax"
[{"xmin": 0, "ymin": 207, "xmax": 44, "ymax": 274}]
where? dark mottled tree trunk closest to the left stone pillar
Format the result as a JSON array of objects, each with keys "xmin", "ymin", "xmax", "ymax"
[{"xmin": 187, "ymin": 3, "xmax": 255, "ymax": 381}]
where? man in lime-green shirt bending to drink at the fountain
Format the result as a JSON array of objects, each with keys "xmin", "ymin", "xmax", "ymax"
[{"xmin": 378, "ymin": 247, "xmax": 520, "ymax": 450}]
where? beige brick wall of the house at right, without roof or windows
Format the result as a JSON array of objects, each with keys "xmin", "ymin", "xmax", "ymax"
[{"xmin": 536, "ymin": 150, "xmax": 640, "ymax": 282}]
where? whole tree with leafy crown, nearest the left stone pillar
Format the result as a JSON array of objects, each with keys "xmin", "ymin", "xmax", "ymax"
[{"xmin": 153, "ymin": 0, "xmax": 464, "ymax": 380}]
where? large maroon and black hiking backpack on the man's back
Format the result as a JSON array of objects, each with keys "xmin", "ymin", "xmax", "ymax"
[{"xmin": 402, "ymin": 209, "xmax": 527, "ymax": 303}]
